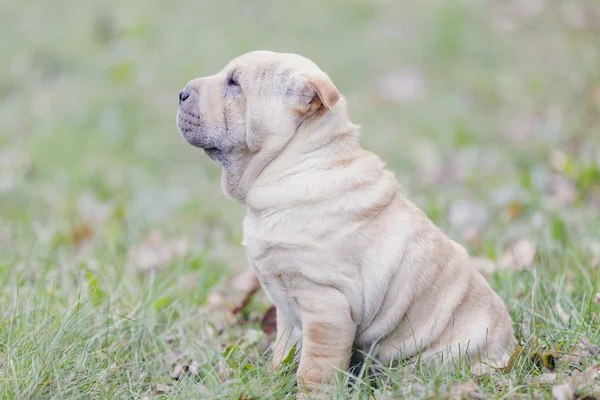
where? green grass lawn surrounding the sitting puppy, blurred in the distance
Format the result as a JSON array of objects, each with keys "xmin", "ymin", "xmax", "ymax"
[{"xmin": 0, "ymin": 0, "xmax": 600, "ymax": 399}]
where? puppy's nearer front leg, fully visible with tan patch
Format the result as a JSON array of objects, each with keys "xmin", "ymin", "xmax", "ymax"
[{"xmin": 296, "ymin": 284, "xmax": 356, "ymax": 391}]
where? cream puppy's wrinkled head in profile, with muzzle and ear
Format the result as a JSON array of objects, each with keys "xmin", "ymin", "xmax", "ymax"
[{"xmin": 177, "ymin": 51, "xmax": 340, "ymax": 166}]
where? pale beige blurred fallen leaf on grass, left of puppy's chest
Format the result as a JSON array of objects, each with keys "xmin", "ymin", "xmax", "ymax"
[{"xmin": 127, "ymin": 231, "xmax": 188, "ymax": 271}]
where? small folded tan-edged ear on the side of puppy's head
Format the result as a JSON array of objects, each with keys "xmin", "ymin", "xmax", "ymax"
[{"xmin": 296, "ymin": 73, "xmax": 340, "ymax": 114}]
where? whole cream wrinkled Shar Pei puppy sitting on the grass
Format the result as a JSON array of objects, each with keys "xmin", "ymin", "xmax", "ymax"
[{"xmin": 178, "ymin": 51, "xmax": 515, "ymax": 390}]
